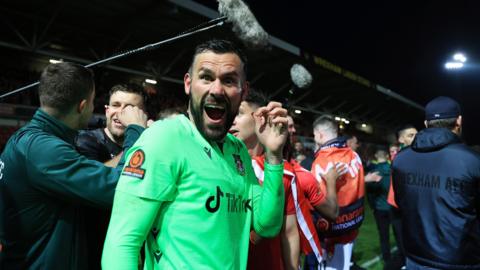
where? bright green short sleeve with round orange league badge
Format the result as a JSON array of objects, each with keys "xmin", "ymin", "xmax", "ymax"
[{"xmin": 117, "ymin": 121, "xmax": 183, "ymax": 201}]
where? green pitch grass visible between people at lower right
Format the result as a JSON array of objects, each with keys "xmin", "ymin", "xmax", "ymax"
[{"xmin": 353, "ymin": 200, "xmax": 396, "ymax": 270}]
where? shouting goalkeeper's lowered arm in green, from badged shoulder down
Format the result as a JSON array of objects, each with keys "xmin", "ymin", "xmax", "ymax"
[{"xmin": 102, "ymin": 122, "xmax": 183, "ymax": 270}]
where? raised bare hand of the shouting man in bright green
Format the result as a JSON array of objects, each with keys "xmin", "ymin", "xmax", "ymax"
[{"xmin": 253, "ymin": 102, "xmax": 288, "ymax": 164}]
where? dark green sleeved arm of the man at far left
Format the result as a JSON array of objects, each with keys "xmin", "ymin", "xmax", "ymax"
[{"xmin": 24, "ymin": 125, "xmax": 144, "ymax": 209}]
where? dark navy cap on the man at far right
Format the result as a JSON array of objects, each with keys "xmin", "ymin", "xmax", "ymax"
[{"xmin": 425, "ymin": 96, "xmax": 460, "ymax": 121}]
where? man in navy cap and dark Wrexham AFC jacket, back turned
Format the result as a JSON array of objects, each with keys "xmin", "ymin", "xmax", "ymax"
[{"xmin": 392, "ymin": 97, "xmax": 480, "ymax": 270}]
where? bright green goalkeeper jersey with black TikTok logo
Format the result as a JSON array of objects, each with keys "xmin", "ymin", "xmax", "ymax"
[{"xmin": 102, "ymin": 116, "xmax": 284, "ymax": 269}]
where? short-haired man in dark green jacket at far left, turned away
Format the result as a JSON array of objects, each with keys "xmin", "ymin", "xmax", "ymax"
[{"xmin": 0, "ymin": 62, "xmax": 144, "ymax": 269}]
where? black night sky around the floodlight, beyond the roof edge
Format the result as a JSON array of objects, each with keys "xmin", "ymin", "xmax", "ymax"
[{"xmin": 225, "ymin": 0, "xmax": 480, "ymax": 144}]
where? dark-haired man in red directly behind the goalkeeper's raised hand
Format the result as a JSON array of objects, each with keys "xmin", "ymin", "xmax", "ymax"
[{"xmin": 230, "ymin": 89, "xmax": 328, "ymax": 269}]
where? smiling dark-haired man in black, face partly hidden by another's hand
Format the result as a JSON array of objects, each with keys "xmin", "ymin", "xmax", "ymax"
[{"xmin": 75, "ymin": 83, "xmax": 147, "ymax": 270}]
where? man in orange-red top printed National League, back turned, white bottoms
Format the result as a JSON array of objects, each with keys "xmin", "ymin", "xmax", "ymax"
[{"xmin": 312, "ymin": 116, "xmax": 365, "ymax": 269}]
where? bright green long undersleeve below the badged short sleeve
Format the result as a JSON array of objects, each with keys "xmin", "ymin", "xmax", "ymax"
[{"xmin": 102, "ymin": 191, "xmax": 162, "ymax": 270}]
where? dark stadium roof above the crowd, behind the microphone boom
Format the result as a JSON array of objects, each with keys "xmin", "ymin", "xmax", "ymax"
[{"xmin": 0, "ymin": 0, "xmax": 423, "ymax": 139}]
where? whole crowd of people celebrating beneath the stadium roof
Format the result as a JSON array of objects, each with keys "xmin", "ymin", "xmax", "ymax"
[{"xmin": 0, "ymin": 40, "xmax": 480, "ymax": 270}]
